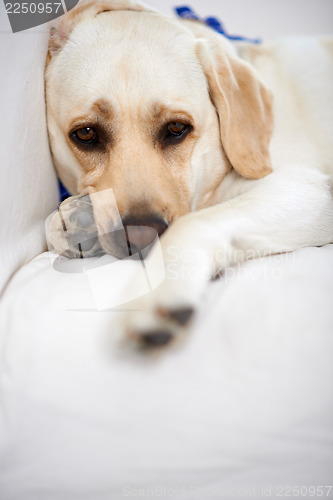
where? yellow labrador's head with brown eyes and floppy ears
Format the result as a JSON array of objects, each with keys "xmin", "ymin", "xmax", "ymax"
[{"xmin": 46, "ymin": 0, "xmax": 272, "ymax": 254}]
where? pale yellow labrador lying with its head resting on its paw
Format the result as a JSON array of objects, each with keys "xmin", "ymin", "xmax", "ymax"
[{"xmin": 46, "ymin": 0, "xmax": 333, "ymax": 345}]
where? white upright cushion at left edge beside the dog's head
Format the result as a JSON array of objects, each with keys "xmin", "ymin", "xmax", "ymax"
[{"xmin": 0, "ymin": 2, "xmax": 58, "ymax": 293}]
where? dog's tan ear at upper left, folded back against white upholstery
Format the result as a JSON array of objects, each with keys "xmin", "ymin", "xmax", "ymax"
[{"xmin": 48, "ymin": 0, "xmax": 155, "ymax": 59}]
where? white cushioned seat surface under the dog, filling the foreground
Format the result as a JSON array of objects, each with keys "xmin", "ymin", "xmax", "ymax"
[{"xmin": 0, "ymin": 245, "xmax": 333, "ymax": 500}]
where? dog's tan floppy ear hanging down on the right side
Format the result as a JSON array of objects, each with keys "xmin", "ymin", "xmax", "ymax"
[{"xmin": 188, "ymin": 22, "xmax": 273, "ymax": 179}]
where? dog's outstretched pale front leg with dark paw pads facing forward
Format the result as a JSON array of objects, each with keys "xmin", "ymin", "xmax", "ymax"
[{"xmin": 122, "ymin": 167, "xmax": 333, "ymax": 345}]
